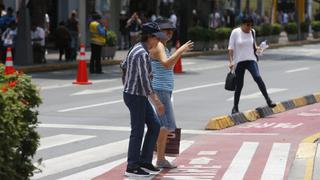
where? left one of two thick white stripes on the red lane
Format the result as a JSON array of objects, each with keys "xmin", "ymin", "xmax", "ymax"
[{"xmin": 222, "ymin": 142, "xmax": 259, "ymax": 180}]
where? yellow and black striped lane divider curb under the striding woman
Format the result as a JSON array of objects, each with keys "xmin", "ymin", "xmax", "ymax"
[{"xmin": 205, "ymin": 92, "xmax": 320, "ymax": 130}]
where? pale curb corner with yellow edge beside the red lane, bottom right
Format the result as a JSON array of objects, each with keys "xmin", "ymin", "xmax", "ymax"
[{"xmin": 288, "ymin": 132, "xmax": 320, "ymax": 180}]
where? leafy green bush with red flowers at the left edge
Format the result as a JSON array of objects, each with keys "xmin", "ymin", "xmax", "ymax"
[{"xmin": 0, "ymin": 64, "xmax": 41, "ymax": 180}]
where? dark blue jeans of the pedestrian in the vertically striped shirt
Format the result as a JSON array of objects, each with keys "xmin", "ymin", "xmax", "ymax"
[{"xmin": 123, "ymin": 93, "xmax": 160, "ymax": 169}]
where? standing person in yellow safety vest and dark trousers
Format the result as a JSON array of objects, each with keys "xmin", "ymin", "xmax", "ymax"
[{"xmin": 89, "ymin": 13, "xmax": 107, "ymax": 74}]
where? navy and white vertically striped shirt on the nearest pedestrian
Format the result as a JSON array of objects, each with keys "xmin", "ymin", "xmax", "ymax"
[{"xmin": 121, "ymin": 43, "xmax": 153, "ymax": 96}]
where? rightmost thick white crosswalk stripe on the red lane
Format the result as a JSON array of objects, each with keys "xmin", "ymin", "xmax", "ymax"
[{"xmin": 261, "ymin": 143, "xmax": 290, "ymax": 180}]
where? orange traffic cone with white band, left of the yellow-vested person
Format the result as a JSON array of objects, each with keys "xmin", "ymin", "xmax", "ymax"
[{"xmin": 73, "ymin": 44, "xmax": 92, "ymax": 85}]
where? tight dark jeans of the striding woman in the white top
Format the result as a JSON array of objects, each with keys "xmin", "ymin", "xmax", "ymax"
[{"xmin": 234, "ymin": 61, "xmax": 270, "ymax": 107}]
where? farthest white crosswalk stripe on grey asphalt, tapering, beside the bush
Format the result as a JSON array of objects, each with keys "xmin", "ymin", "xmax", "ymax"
[{"xmin": 38, "ymin": 134, "xmax": 96, "ymax": 151}]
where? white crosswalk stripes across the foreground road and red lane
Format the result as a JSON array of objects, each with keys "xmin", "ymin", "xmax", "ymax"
[{"xmin": 32, "ymin": 131, "xmax": 292, "ymax": 180}]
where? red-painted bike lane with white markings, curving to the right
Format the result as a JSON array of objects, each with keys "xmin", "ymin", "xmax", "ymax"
[{"xmin": 95, "ymin": 103, "xmax": 320, "ymax": 180}]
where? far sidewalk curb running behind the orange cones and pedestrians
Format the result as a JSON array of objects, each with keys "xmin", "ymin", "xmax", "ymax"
[{"xmin": 15, "ymin": 39, "xmax": 320, "ymax": 73}]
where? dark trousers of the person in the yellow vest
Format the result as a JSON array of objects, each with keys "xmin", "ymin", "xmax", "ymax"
[{"xmin": 90, "ymin": 44, "xmax": 102, "ymax": 73}]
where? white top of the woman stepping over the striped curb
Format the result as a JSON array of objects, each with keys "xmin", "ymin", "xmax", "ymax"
[{"xmin": 228, "ymin": 27, "xmax": 257, "ymax": 64}]
